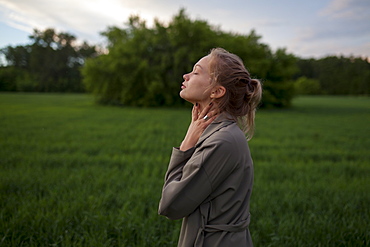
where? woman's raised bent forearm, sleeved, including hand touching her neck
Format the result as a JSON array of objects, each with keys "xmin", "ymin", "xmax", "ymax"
[{"xmin": 159, "ymin": 103, "xmax": 217, "ymax": 219}]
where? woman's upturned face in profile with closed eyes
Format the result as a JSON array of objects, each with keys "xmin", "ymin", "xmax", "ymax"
[{"xmin": 180, "ymin": 56, "xmax": 211, "ymax": 104}]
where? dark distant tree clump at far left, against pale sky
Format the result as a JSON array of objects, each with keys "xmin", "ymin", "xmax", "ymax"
[{"xmin": 0, "ymin": 28, "xmax": 96, "ymax": 92}]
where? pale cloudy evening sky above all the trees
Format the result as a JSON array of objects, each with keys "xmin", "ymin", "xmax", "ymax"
[{"xmin": 0, "ymin": 0, "xmax": 370, "ymax": 58}]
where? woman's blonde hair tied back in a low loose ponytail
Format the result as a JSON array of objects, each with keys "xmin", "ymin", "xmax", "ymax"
[{"xmin": 209, "ymin": 48, "xmax": 262, "ymax": 140}]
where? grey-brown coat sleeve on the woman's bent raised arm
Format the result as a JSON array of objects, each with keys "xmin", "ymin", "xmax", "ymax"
[{"xmin": 158, "ymin": 137, "xmax": 236, "ymax": 219}]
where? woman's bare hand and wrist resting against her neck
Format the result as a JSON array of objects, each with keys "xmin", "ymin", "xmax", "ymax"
[{"xmin": 180, "ymin": 102, "xmax": 217, "ymax": 151}]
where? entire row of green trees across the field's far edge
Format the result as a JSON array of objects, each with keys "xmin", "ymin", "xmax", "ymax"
[{"xmin": 0, "ymin": 9, "xmax": 370, "ymax": 107}]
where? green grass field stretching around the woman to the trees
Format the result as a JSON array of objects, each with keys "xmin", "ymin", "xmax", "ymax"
[{"xmin": 0, "ymin": 93, "xmax": 370, "ymax": 247}]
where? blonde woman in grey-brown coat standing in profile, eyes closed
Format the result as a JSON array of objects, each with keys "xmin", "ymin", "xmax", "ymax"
[{"xmin": 159, "ymin": 48, "xmax": 262, "ymax": 247}]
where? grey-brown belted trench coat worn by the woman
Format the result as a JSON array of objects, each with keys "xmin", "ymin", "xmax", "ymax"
[{"xmin": 158, "ymin": 114, "xmax": 253, "ymax": 247}]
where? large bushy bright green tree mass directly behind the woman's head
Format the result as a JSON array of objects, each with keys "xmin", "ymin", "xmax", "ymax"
[{"xmin": 82, "ymin": 9, "xmax": 296, "ymax": 107}]
